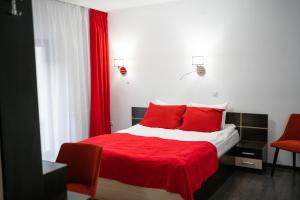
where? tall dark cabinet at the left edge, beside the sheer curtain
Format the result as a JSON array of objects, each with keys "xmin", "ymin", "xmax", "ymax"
[{"xmin": 0, "ymin": 0, "xmax": 43, "ymax": 200}]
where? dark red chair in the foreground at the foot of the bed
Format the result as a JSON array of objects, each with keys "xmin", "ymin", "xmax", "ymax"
[{"xmin": 56, "ymin": 143, "xmax": 102, "ymax": 199}]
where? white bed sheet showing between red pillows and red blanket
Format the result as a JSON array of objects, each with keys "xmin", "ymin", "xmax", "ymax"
[{"xmin": 117, "ymin": 124, "xmax": 240, "ymax": 157}]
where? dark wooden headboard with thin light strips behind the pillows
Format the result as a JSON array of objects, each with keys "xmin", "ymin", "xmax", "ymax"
[{"xmin": 131, "ymin": 107, "xmax": 268, "ymax": 142}]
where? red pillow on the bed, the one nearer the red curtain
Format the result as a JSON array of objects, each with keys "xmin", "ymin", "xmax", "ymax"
[{"xmin": 140, "ymin": 103, "xmax": 186, "ymax": 129}]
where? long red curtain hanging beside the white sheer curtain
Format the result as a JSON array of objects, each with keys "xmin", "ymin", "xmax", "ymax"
[{"xmin": 90, "ymin": 9, "xmax": 111, "ymax": 137}]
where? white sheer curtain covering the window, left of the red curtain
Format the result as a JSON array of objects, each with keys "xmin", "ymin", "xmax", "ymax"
[{"xmin": 32, "ymin": 0, "xmax": 90, "ymax": 161}]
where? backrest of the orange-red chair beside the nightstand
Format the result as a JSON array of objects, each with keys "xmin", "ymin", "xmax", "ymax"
[{"xmin": 280, "ymin": 114, "xmax": 300, "ymax": 140}]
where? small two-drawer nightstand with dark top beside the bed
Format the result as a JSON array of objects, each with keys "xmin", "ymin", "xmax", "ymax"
[{"xmin": 233, "ymin": 140, "xmax": 267, "ymax": 170}]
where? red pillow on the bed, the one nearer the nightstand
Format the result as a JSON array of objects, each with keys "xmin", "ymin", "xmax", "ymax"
[{"xmin": 179, "ymin": 107, "xmax": 224, "ymax": 132}]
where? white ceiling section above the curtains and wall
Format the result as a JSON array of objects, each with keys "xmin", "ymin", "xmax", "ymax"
[{"xmin": 59, "ymin": 0, "xmax": 178, "ymax": 12}]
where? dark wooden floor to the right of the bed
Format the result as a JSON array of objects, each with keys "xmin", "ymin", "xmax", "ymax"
[{"xmin": 210, "ymin": 167, "xmax": 300, "ymax": 200}]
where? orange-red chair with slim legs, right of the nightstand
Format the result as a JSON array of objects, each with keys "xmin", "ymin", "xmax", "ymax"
[{"xmin": 271, "ymin": 114, "xmax": 300, "ymax": 176}]
